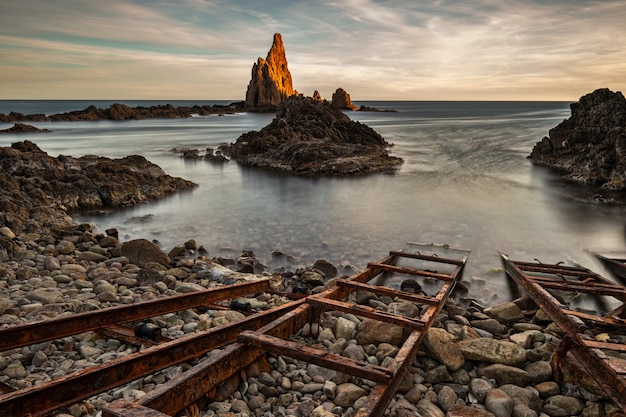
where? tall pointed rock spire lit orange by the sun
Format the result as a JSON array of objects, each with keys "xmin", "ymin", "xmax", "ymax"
[{"xmin": 245, "ymin": 33, "xmax": 297, "ymax": 111}]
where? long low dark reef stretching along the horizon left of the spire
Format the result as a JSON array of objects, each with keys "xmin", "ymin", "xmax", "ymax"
[{"xmin": 0, "ymin": 102, "xmax": 243, "ymax": 123}]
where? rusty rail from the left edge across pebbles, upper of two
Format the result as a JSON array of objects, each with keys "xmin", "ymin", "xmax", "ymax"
[{"xmin": 0, "ymin": 278, "xmax": 270, "ymax": 351}]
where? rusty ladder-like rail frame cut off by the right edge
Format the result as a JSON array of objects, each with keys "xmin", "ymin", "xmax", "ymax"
[{"xmin": 500, "ymin": 253, "xmax": 626, "ymax": 412}]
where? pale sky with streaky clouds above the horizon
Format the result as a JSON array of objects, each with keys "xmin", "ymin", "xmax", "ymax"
[{"xmin": 0, "ymin": 0, "xmax": 626, "ymax": 102}]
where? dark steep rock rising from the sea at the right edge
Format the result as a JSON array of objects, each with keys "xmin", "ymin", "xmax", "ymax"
[{"xmin": 529, "ymin": 88, "xmax": 626, "ymax": 190}]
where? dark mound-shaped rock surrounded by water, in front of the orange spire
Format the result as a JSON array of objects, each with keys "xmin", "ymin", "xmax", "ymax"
[{"xmin": 222, "ymin": 96, "xmax": 402, "ymax": 175}]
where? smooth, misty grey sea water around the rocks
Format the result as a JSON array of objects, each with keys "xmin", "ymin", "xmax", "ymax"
[{"xmin": 0, "ymin": 100, "xmax": 626, "ymax": 305}]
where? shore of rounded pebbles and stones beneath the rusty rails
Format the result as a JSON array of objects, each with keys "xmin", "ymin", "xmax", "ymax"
[{"xmin": 0, "ymin": 222, "xmax": 623, "ymax": 417}]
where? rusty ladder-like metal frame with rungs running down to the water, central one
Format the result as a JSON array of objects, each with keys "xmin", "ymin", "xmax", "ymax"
[{"xmin": 103, "ymin": 244, "xmax": 469, "ymax": 417}]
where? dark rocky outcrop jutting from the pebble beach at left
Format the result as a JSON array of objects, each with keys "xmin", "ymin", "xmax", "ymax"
[{"xmin": 0, "ymin": 141, "xmax": 195, "ymax": 231}]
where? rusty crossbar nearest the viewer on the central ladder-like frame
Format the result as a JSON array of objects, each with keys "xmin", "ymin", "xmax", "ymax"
[{"xmin": 238, "ymin": 331, "xmax": 392, "ymax": 384}]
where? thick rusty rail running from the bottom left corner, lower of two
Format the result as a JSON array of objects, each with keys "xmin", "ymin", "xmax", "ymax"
[{"xmin": 0, "ymin": 300, "xmax": 303, "ymax": 417}]
